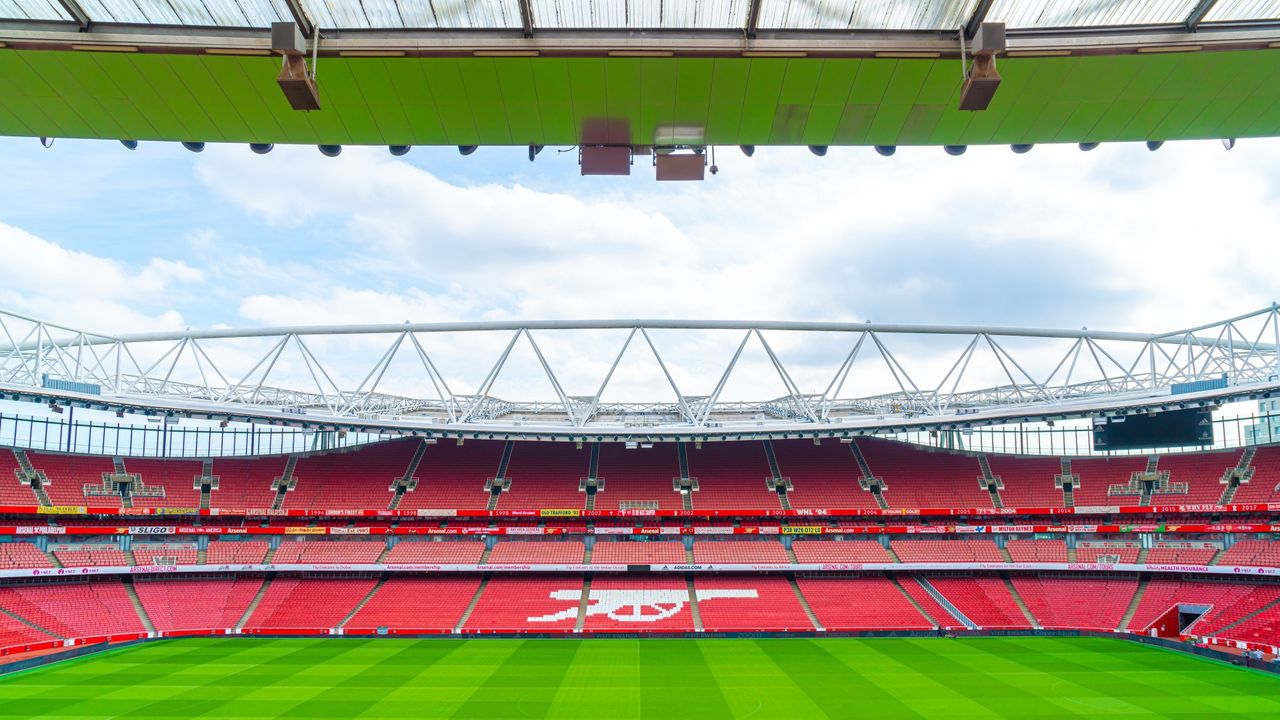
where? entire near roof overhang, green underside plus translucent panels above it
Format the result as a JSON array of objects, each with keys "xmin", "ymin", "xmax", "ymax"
[{"xmin": 0, "ymin": 0, "xmax": 1280, "ymax": 146}]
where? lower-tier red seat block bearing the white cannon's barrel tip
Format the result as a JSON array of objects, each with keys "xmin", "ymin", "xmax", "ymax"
[{"xmin": 694, "ymin": 575, "xmax": 814, "ymax": 633}]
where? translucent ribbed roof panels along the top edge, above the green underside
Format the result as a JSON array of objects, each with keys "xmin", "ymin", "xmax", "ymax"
[{"xmin": 0, "ymin": 0, "xmax": 1280, "ymax": 33}]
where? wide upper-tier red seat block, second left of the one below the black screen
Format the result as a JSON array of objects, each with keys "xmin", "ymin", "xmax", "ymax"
[{"xmin": 855, "ymin": 438, "xmax": 992, "ymax": 509}]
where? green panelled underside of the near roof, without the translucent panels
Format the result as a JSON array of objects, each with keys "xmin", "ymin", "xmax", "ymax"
[{"xmin": 0, "ymin": 50, "xmax": 1280, "ymax": 145}]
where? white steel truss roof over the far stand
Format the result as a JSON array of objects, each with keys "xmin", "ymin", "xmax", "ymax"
[{"xmin": 0, "ymin": 305, "xmax": 1280, "ymax": 438}]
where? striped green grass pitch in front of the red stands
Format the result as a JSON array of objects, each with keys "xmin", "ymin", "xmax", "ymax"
[{"xmin": 0, "ymin": 638, "xmax": 1280, "ymax": 720}]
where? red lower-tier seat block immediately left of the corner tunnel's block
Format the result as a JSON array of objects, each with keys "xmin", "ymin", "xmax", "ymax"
[{"xmin": 1012, "ymin": 575, "xmax": 1138, "ymax": 632}]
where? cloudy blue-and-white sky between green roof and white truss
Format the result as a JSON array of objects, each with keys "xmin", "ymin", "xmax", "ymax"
[{"xmin": 0, "ymin": 138, "xmax": 1280, "ymax": 398}]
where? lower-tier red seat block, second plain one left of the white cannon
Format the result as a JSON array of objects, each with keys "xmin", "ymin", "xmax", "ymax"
[{"xmin": 244, "ymin": 578, "xmax": 378, "ymax": 629}]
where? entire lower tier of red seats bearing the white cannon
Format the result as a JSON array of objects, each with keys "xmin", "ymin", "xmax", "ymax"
[{"xmin": 0, "ymin": 573, "xmax": 1280, "ymax": 648}]
